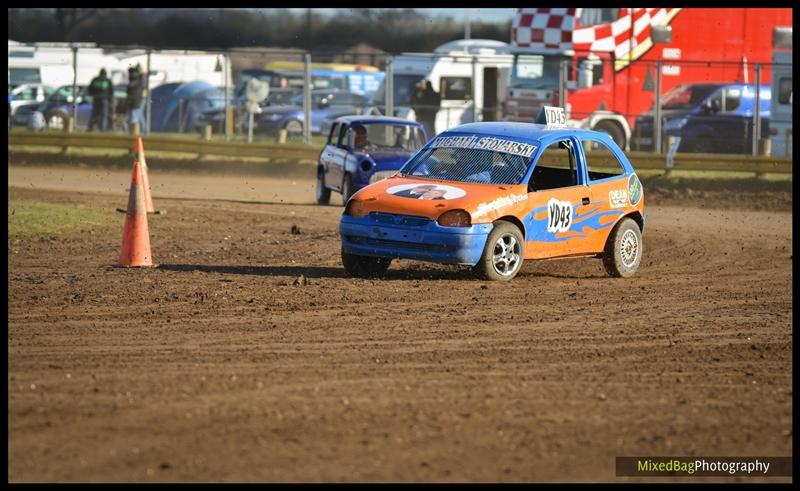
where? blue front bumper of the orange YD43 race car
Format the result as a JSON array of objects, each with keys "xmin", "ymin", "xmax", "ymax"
[{"xmin": 339, "ymin": 213, "xmax": 493, "ymax": 266}]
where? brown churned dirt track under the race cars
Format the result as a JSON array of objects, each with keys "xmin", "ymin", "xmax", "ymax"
[{"xmin": 8, "ymin": 166, "xmax": 792, "ymax": 482}]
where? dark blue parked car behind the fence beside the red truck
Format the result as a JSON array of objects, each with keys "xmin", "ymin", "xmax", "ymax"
[{"xmin": 631, "ymin": 83, "xmax": 772, "ymax": 154}]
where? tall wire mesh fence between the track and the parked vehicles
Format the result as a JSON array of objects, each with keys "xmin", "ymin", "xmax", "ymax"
[{"xmin": 9, "ymin": 45, "xmax": 792, "ymax": 156}]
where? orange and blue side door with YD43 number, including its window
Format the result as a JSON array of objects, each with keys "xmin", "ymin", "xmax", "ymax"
[{"xmin": 524, "ymin": 137, "xmax": 593, "ymax": 259}]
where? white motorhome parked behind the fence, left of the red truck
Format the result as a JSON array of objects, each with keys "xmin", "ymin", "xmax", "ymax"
[{"xmin": 366, "ymin": 39, "xmax": 514, "ymax": 137}]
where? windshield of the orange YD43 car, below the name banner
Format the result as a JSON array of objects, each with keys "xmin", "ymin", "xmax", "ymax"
[{"xmin": 400, "ymin": 147, "xmax": 531, "ymax": 184}]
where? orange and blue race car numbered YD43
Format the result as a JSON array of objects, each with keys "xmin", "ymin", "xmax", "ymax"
[{"xmin": 339, "ymin": 108, "xmax": 645, "ymax": 280}]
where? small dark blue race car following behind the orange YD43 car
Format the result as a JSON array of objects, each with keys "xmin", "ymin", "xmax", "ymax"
[{"xmin": 317, "ymin": 116, "xmax": 426, "ymax": 205}]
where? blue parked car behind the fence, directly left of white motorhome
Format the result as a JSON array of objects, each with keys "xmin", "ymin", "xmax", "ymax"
[{"xmin": 253, "ymin": 90, "xmax": 367, "ymax": 135}]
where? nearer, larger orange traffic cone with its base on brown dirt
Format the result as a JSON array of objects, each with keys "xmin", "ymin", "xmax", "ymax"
[{"xmin": 119, "ymin": 161, "xmax": 153, "ymax": 267}]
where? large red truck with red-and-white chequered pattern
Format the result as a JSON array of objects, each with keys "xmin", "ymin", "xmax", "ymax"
[{"xmin": 503, "ymin": 8, "xmax": 792, "ymax": 149}]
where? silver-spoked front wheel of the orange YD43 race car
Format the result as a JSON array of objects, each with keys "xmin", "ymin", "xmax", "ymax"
[{"xmin": 473, "ymin": 221, "xmax": 525, "ymax": 281}]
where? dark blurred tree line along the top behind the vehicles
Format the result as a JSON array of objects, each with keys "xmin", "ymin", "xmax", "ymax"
[{"xmin": 8, "ymin": 8, "xmax": 511, "ymax": 54}]
